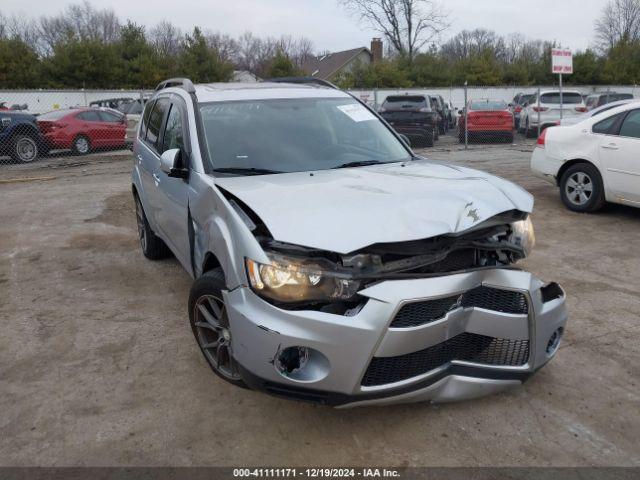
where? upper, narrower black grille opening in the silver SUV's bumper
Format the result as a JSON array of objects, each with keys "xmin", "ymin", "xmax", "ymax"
[{"xmin": 391, "ymin": 286, "xmax": 529, "ymax": 328}]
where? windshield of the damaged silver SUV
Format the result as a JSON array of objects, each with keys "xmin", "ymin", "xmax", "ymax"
[{"xmin": 200, "ymin": 98, "xmax": 411, "ymax": 174}]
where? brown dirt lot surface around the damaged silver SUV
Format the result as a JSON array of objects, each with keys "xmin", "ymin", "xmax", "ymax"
[{"xmin": 0, "ymin": 135, "xmax": 640, "ymax": 466}]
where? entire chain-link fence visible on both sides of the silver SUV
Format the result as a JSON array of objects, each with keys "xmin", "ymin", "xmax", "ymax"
[{"xmin": 0, "ymin": 85, "xmax": 640, "ymax": 165}]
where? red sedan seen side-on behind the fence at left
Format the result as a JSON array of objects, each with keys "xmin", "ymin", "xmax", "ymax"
[{"xmin": 37, "ymin": 108, "xmax": 127, "ymax": 154}]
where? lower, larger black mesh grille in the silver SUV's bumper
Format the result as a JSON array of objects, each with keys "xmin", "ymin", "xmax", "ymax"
[{"xmin": 362, "ymin": 332, "xmax": 529, "ymax": 387}]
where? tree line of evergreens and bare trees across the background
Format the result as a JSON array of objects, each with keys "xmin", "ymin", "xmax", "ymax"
[{"xmin": 0, "ymin": 0, "xmax": 640, "ymax": 88}]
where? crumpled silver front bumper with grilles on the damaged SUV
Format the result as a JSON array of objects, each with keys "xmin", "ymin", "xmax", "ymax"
[{"xmin": 225, "ymin": 269, "xmax": 567, "ymax": 407}]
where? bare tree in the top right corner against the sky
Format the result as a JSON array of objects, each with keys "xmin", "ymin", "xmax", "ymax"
[{"xmin": 595, "ymin": 0, "xmax": 640, "ymax": 52}]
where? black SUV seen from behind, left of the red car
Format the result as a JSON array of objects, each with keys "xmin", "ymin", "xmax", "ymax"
[{"xmin": 379, "ymin": 95, "xmax": 439, "ymax": 147}]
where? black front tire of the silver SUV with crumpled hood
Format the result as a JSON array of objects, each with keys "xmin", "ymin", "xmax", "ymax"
[{"xmin": 189, "ymin": 268, "xmax": 248, "ymax": 388}]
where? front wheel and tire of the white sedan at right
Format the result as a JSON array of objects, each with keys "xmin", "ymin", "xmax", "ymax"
[{"xmin": 560, "ymin": 163, "xmax": 606, "ymax": 213}]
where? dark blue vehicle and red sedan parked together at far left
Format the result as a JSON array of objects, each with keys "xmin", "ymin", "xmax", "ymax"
[{"xmin": 0, "ymin": 108, "xmax": 127, "ymax": 163}]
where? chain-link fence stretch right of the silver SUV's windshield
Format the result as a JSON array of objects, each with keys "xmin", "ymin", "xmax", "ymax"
[{"xmin": 352, "ymin": 85, "xmax": 640, "ymax": 148}]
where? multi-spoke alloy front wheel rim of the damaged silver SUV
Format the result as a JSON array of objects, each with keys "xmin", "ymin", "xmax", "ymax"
[{"xmin": 193, "ymin": 295, "xmax": 241, "ymax": 381}]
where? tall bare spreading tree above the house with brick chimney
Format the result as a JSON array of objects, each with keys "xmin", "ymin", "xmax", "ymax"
[{"xmin": 338, "ymin": 0, "xmax": 449, "ymax": 62}]
